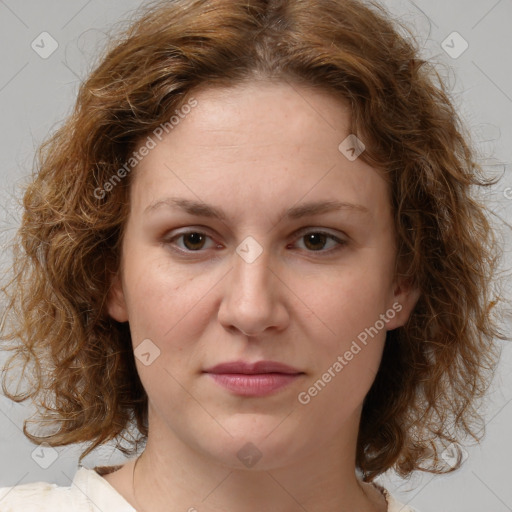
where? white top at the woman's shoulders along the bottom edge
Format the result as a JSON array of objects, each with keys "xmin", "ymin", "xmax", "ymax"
[{"xmin": 0, "ymin": 467, "xmax": 419, "ymax": 512}]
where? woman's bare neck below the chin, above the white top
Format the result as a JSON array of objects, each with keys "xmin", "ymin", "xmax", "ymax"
[{"xmin": 132, "ymin": 406, "xmax": 387, "ymax": 512}]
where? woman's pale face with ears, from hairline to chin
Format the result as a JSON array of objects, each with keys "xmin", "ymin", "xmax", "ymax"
[{"xmin": 109, "ymin": 82, "xmax": 417, "ymax": 468}]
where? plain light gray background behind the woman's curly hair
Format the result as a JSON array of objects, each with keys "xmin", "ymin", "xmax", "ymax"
[{"xmin": 0, "ymin": 0, "xmax": 512, "ymax": 512}]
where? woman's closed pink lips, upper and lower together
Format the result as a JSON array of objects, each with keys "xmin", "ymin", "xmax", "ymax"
[{"xmin": 204, "ymin": 361, "xmax": 304, "ymax": 397}]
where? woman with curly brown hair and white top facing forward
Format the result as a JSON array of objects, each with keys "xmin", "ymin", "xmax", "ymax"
[{"xmin": 0, "ymin": 0, "xmax": 502, "ymax": 512}]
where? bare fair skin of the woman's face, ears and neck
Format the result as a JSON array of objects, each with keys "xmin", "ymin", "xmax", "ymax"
[{"xmin": 105, "ymin": 81, "xmax": 418, "ymax": 512}]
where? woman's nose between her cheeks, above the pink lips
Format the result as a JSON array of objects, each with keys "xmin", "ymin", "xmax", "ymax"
[{"xmin": 218, "ymin": 247, "xmax": 289, "ymax": 337}]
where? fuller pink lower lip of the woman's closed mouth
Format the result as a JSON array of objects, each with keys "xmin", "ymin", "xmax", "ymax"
[{"xmin": 208, "ymin": 373, "xmax": 301, "ymax": 396}]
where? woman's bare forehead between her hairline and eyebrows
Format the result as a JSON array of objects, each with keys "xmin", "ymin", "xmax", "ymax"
[{"xmin": 127, "ymin": 82, "xmax": 387, "ymax": 222}]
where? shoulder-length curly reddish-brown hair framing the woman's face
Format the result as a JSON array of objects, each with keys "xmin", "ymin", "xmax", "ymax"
[{"xmin": 1, "ymin": 0, "xmax": 506, "ymax": 482}]
